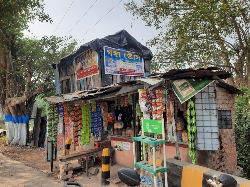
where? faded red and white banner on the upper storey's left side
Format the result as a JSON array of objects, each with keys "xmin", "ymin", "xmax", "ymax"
[{"xmin": 75, "ymin": 49, "xmax": 99, "ymax": 80}]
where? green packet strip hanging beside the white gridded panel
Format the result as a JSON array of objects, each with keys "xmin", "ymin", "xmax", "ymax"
[{"xmin": 187, "ymin": 99, "xmax": 196, "ymax": 164}]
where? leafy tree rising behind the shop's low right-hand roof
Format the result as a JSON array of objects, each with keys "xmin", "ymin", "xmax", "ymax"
[{"xmin": 125, "ymin": 0, "xmax": 250, "ymax": 87}]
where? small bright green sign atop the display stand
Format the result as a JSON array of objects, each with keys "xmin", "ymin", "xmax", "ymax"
[{"xmin": 142, "ymin": 119, "xmax": 163, "ymax": 134}]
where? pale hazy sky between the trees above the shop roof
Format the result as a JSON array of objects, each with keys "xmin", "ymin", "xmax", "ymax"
[{"xmin": 24, "ymin": 0, "xmax": 158, "ymax": 50}]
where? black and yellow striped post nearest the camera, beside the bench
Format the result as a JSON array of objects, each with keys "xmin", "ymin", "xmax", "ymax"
[{"xmin": 101, "ymin": 148, "xmax": 110, "ymax": 186}]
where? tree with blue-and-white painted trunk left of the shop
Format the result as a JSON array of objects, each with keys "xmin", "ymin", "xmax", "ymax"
[{"xmin": 0, "ymin": 0, "xmax": 75, "ymax": 145}]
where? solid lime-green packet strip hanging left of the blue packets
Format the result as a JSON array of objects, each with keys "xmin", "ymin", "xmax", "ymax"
[{"xmin": 80, "ymin": 103, "xmax": 91, "ymax": 145}]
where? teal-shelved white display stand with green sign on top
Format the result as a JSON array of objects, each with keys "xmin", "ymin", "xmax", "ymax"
[{"xmin": 132, "ymin": 119, "xmax": 168, "ymax": 187}]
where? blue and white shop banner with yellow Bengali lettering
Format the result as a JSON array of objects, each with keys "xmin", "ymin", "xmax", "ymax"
[{"xmin": 103, "ymin": 46, "xmax": 144, "ymax": 76}]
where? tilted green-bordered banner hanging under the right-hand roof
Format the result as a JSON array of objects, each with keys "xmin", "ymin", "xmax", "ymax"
[{"xmin": 171, "ymin": 79, "xmax": 214, "ymax": 103}]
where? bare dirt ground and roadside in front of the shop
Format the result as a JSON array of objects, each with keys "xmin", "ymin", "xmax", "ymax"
[{"xmin": 0, "ymin": 141, "xmax": 119, "ymax": 187}]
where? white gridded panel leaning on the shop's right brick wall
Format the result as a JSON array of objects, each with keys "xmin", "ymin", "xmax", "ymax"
[{"xmin": 195, "ymin": 83, "xmax": 219, "ymax": 150}]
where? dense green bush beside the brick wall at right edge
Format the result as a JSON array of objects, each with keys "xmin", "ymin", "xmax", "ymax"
[{"xmin": 235, "ymin": 87, "xmax": 250, "ymax": 179}]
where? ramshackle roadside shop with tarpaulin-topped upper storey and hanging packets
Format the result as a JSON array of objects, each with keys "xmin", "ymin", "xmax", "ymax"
[{"xmin": 47, "ymin": 31, "xmax": 241, "ymax": 173}]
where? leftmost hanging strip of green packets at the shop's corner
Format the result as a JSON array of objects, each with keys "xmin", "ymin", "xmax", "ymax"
[{"xmin": 47, "ymin": 103, "xmax": 59, "ymax": 146}]
